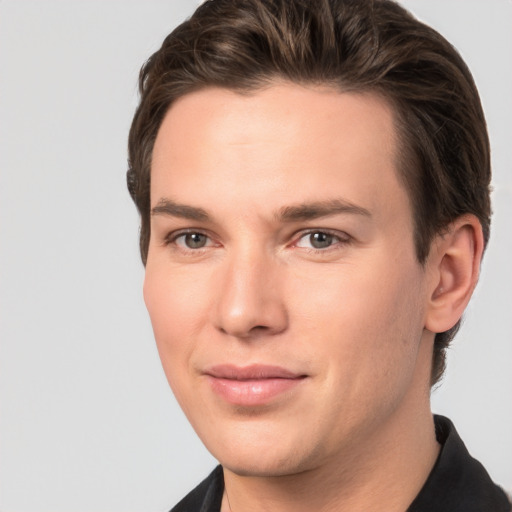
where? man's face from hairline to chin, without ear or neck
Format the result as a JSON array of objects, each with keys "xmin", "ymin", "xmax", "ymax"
[{"xmin": 144, "ymin": 84, "xmax": 431, "ymax": 475}]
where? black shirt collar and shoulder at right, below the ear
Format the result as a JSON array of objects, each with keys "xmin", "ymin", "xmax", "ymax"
[{"xmin": 408, "ymin": 416, "xmax": 512, "ymax": 512}]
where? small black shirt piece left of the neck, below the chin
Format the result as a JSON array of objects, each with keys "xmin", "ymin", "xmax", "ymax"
[{"xmin": 170, "ymin": 466, "xmax": 224, "ymax": 512}]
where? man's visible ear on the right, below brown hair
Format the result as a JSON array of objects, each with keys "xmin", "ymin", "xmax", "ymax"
[{"xmin": 425, "ymin": 215, "xmax": 484, "ymax": 333}]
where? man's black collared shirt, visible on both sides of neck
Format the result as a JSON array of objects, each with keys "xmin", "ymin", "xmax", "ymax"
[{"xmin": 171, "ymin": 416, "xmax": 512, "ymax": 512}]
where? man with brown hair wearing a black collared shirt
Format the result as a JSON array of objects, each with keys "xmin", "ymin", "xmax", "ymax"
[{"xmin": 128, "ymin": 0, "xmax": 510, "ymax": 512}]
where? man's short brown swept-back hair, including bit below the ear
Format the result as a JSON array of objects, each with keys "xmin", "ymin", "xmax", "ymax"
[{"xmin": 127, "ymin": 0, "xmax": 491, "ymax": 384}]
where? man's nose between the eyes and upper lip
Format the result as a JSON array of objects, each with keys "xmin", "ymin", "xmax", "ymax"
[{"xmin": 216, "ymin": 251, "xmax": 288, "ymax": 339}]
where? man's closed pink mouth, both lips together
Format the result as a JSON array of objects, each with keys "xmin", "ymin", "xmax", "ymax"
[{"xmin": 204, "ymin": 365, "xmax": 307, "ymax": 407}]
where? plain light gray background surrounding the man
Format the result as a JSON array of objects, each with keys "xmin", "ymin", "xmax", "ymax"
[{"xmin": 0, "ymin": 0, "xmax": 512, "ymax": 512}]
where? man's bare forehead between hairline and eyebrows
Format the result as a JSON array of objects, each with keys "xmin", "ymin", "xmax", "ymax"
[{"xmin": 151, "ymin": 84, "xmax": 408, "ymax": 224}]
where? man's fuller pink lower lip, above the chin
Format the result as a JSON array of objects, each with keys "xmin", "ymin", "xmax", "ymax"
[{"xmin": 208, "ymin": 376, "xmax": 304, "ymax": 407}]
